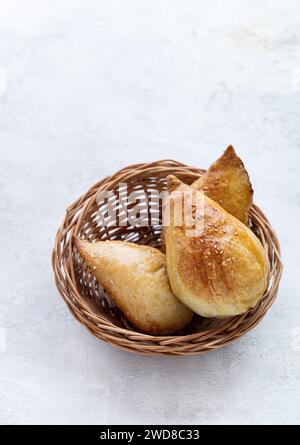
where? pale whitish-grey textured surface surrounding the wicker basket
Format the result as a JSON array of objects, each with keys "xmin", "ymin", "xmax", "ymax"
[{"xmin": 0, "ymin": 0, "xmax": 300, "ymax": 424}]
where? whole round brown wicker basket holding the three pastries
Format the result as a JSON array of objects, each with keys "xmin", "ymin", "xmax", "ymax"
[{"xmin": 52, "ymin": 160, "xmax": 282, "ymax": 355}]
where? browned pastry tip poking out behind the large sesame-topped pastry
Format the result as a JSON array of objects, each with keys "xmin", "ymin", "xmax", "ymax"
[{"xmin": 192, "ymin": 145, "xmax": 253, "ymax": 225}]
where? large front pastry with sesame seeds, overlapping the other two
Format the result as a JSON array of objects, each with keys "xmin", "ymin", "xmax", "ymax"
[{"xmin": 163, "ymin": 176, "xmax": 269, "ymax": 317}]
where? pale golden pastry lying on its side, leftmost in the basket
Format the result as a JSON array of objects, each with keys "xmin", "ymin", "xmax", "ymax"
[{"xmin": 75, "ymin": 238, "xmax": 193, "ymax": 335}]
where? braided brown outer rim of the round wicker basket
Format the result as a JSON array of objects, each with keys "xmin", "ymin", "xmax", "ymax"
[{"xmin": 52, "ymin": 159, "xmax": 283, "ymax": 355}]
